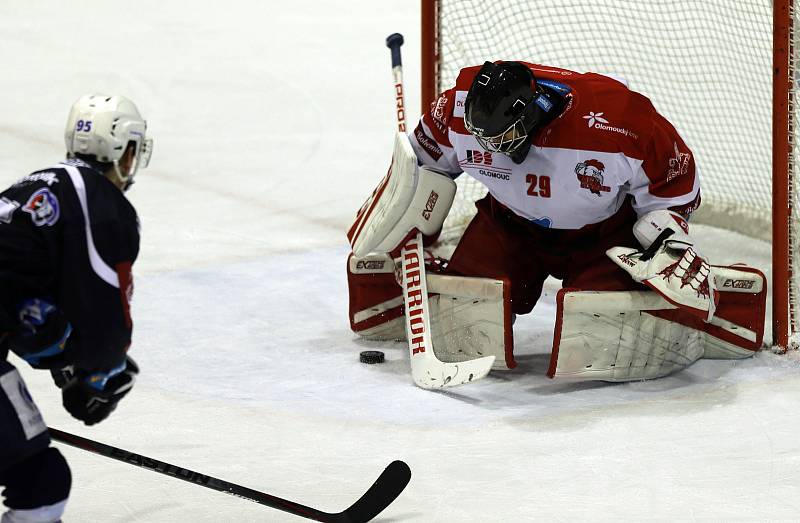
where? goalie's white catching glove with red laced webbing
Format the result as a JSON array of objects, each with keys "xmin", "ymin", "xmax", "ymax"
[{"xmin": 606, "ymin": 210, "xmax": 719, "ymax": 321}]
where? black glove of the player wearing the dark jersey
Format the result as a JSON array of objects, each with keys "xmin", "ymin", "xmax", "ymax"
[{"xmin": 61, "ymin": 356, "xmax": 139, "ymax": 425}]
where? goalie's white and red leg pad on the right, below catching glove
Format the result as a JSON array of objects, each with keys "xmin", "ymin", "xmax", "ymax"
[{"xmin": 548, "ymin": 266, "xmax": 767, "ymax": 381}]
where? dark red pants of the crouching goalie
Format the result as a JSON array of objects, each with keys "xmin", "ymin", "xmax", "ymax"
[{"xmin": 446, "ymin": 195, "xmax": 645, "ymax": 314}]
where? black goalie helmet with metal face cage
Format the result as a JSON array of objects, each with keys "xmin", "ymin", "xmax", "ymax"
[{"xmin": 464, "ymin": 62, "xmax": 562, "ymax": 163}]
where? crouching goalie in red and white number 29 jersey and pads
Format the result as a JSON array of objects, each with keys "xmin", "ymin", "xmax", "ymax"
[{"xmin": 348, "ymin": 62, "xmax": 766, "ymax": 381}]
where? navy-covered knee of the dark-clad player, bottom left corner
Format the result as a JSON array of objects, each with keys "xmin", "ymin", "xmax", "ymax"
[{"xmin": 0, "ymin": 447, "xmax": 72, "ymax": 523}]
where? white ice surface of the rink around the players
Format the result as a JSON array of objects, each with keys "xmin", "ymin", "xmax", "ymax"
[{"xmin": 0, "ymin": 0, "xmax": 800, "ymax": 523}]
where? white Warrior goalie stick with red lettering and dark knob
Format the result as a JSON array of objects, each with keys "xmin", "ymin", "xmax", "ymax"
[{"xmin": 386, "ymin": 33, "xmax": 494, "ymax": 389}]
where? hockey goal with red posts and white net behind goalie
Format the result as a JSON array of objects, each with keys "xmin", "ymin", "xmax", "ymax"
[{"xmin": 421, "ymin": 0, "xmax": 800, "ymax": 348}]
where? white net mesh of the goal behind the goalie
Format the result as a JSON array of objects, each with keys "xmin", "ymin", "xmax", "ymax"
[{"xmin": 437, "ymin": 0, "xmax": 798, "ymax": 336}]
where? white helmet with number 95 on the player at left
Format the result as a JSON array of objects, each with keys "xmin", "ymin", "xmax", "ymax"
[{"xmin": 64, "ymin": 94, "xmax": 153, "ymax": 190}]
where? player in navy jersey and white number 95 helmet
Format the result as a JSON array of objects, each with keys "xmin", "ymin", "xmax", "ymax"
[{"xmin": 0, "ymin": 94, "xmax": 152, "ymax": 523}]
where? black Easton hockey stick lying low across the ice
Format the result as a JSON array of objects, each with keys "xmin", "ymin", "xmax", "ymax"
[{"xmin": 49, "ymin": 428, "xmax": 411, "ymax": 523}]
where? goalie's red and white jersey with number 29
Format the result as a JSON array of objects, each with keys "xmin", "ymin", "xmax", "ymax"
[{"xmin": 411, "ymin": 64, "xmax": 700, "ymax": 229}]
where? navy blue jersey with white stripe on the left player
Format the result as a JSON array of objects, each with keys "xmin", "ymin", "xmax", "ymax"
[{"xmin": 0, "ymin": 159, "xmax": 139, "ymax": 371}]
